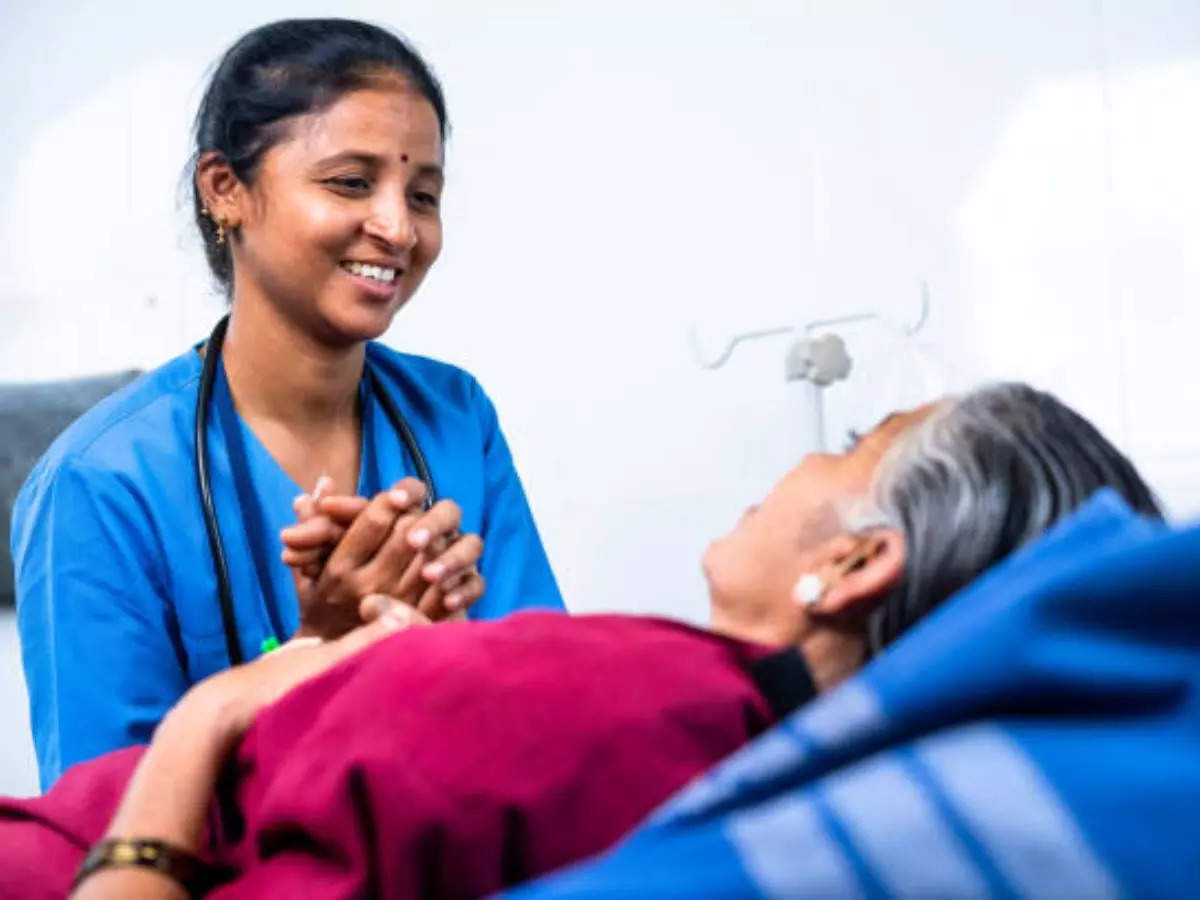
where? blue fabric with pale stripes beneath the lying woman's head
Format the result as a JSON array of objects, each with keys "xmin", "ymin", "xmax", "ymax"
[{"xmin": 512, "ymin": 492, "xmax": 1200, "ymax": 898}]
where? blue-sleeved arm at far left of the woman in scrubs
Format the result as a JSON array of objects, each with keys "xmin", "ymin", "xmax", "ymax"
[{"xmin": 13, "ymin": 460, "xmax": 188, "ymax": 790}]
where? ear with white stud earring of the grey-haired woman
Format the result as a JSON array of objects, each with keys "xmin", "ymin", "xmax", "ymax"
[{"xmin": 793, "ymin": 528, "xmax": 907, "ymax": 624}]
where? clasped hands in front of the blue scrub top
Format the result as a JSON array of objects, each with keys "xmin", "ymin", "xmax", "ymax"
[{"xmin": 281, "ymin": 479, "xmax": 484, "ymax": 637}]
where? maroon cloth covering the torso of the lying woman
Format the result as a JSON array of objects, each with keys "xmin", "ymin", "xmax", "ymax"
[{"xmin": 0, "ymin": 612, "xmax": 772, "ymax": 898}]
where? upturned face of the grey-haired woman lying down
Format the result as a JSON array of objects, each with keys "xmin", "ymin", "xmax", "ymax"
[{"xmin": 703, "ymin": 407, "xmax": 931, "ymax": 619}]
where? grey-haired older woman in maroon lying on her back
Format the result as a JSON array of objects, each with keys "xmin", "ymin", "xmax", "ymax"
[{"xmin": 0, "ymin": 385, "xmax": 1158, "ymax": 898}]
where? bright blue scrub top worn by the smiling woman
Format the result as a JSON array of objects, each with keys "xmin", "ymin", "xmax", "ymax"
[{"xmin": 12, "ymin": 343, "xmax": 563, "ymax": 790}]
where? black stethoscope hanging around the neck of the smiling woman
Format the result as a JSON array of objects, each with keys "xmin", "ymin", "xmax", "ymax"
[{"xmin": 196, "ymin": 316, "xmax": 437, "ymax": 666}]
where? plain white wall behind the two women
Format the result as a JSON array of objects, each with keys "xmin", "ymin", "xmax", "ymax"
[{"xmin": 0, "ymin": 0, "xmax": 1200, "ymax": 790}]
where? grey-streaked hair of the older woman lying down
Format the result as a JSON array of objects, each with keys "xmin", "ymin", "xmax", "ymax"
[{"xmin": 858, "ymin": 383, "xmax": 1163, "ymax": 652}]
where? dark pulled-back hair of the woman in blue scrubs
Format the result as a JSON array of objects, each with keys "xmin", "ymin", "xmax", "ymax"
[{"xmin": 191, "ymin": 19, "xmax": 448, "ymax": 290}]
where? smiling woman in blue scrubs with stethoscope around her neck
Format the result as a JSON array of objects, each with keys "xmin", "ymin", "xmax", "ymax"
[{"xmin": 13, "ymin": 19, "xmax": 562, "ymax": 787}]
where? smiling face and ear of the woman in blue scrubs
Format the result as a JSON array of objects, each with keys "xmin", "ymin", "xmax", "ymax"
[{"xmin": 196, "ymin": 70, "xmax": 444, "ymax": 345}]
